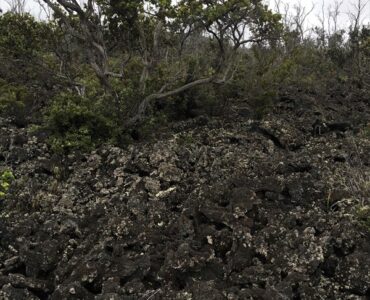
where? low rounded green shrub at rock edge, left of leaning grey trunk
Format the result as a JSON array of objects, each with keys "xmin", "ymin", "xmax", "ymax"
[{"xmin": 46, "ymin": 92, "xmax": 117, "ymax": 153}]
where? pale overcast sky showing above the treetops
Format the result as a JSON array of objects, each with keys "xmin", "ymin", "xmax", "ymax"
[{"xmin": 0, "ymin": 0, "xmax": 370, "ymax": 28}]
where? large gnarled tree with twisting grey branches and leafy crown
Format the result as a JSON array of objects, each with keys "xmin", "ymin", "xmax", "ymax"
[{"xmin": 43, "ymin": 0, "xmax": 280, "ymax": 123}]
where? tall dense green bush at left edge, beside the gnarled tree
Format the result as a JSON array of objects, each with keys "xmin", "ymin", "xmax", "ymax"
[{"xmin": 0, "ymin": 12, "xmax": 60, "ymax": 126}]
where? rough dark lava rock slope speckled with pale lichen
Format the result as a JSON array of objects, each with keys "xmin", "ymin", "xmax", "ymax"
[{"xmin": 0, "ymin": 92, "xmax": 370, "ymax": 300}]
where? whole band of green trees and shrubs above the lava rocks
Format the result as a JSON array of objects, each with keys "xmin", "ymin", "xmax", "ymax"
[{"xmin": 0, "ymin": 0, "xmax": 370, "ymax": 153}]
